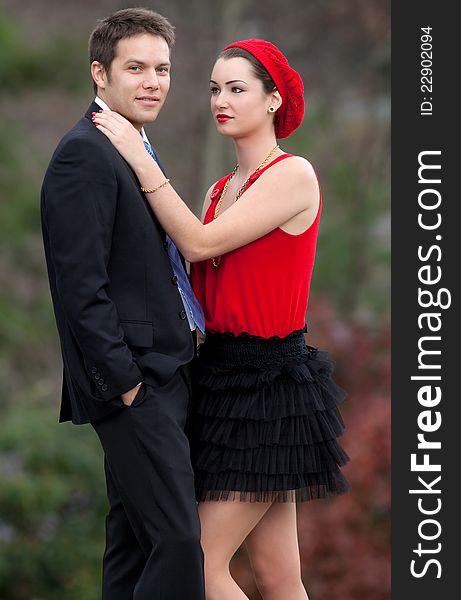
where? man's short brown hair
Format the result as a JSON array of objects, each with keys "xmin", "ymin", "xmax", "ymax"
[{"xmin": 88, "ymin": 8, "xmax": 175, "ymax": 92}]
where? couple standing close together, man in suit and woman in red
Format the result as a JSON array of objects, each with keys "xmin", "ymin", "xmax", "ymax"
[{"xmin": 41, "ymin": 8, "xmax": 347, "ymax": 600}]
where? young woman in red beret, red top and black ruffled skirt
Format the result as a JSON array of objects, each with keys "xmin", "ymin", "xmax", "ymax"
[{"xmin": 94, "ymin": 39, "xmax": 348, "ymax": 600}]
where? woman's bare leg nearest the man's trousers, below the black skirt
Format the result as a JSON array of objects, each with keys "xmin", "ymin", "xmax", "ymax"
[{"xmin": 198, "ymin": 501, "xmax": 271, "ymax": 600}]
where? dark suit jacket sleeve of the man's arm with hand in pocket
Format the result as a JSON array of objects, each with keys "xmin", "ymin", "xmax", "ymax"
[{"xmin": 43, "ymin": 136, "xmax": 143, "ymax": 400}]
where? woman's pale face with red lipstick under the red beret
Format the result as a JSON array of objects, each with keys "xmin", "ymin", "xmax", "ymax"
[{"xmin": 210, "ymin": 57, "xmax": 273, "ymax": 138}]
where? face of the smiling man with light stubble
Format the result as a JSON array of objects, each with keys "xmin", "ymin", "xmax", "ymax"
[{"xmin": 92, "ymin": 33, "xmax": 170, "ymax": 130}]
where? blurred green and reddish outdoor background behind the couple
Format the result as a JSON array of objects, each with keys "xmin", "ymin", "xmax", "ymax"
[{"xmin": 0, "ymin": 0, "xmax": 390, "ymax": 600}]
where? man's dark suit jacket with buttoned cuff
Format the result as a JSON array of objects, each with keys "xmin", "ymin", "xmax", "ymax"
[{"xmin": 41, "ymin": 103, "xmax": 194, "ymax": 423}]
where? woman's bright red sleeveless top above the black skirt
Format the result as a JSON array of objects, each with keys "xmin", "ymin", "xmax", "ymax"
[{"xmin": 191, "ymin": 154, "xmax": 322, "ymax": 338}]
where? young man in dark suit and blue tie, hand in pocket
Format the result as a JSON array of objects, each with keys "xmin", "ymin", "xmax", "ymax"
[{"xmin": 41, "ymin": 8, "xmax": 204, "ymax": 600}]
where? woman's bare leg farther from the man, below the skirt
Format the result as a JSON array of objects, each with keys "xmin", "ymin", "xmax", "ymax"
[{"xmin": 245, "ymin": 502, "xmax": 308, "ymax": 600}]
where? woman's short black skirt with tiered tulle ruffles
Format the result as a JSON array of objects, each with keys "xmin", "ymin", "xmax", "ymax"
[{"xmin": 189, "ymin": 331, "xmax": 349, "ymax": 502}]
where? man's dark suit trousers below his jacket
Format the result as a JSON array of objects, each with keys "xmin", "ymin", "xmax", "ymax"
[{"xmin": 93, "ymin": 367, "xmax": 204, "ymax": 600}]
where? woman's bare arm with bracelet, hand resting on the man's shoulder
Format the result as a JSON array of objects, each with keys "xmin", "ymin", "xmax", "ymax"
[{"xmin": 91, "ymin": 112, "xmax": 319, "ymax": 262}]
